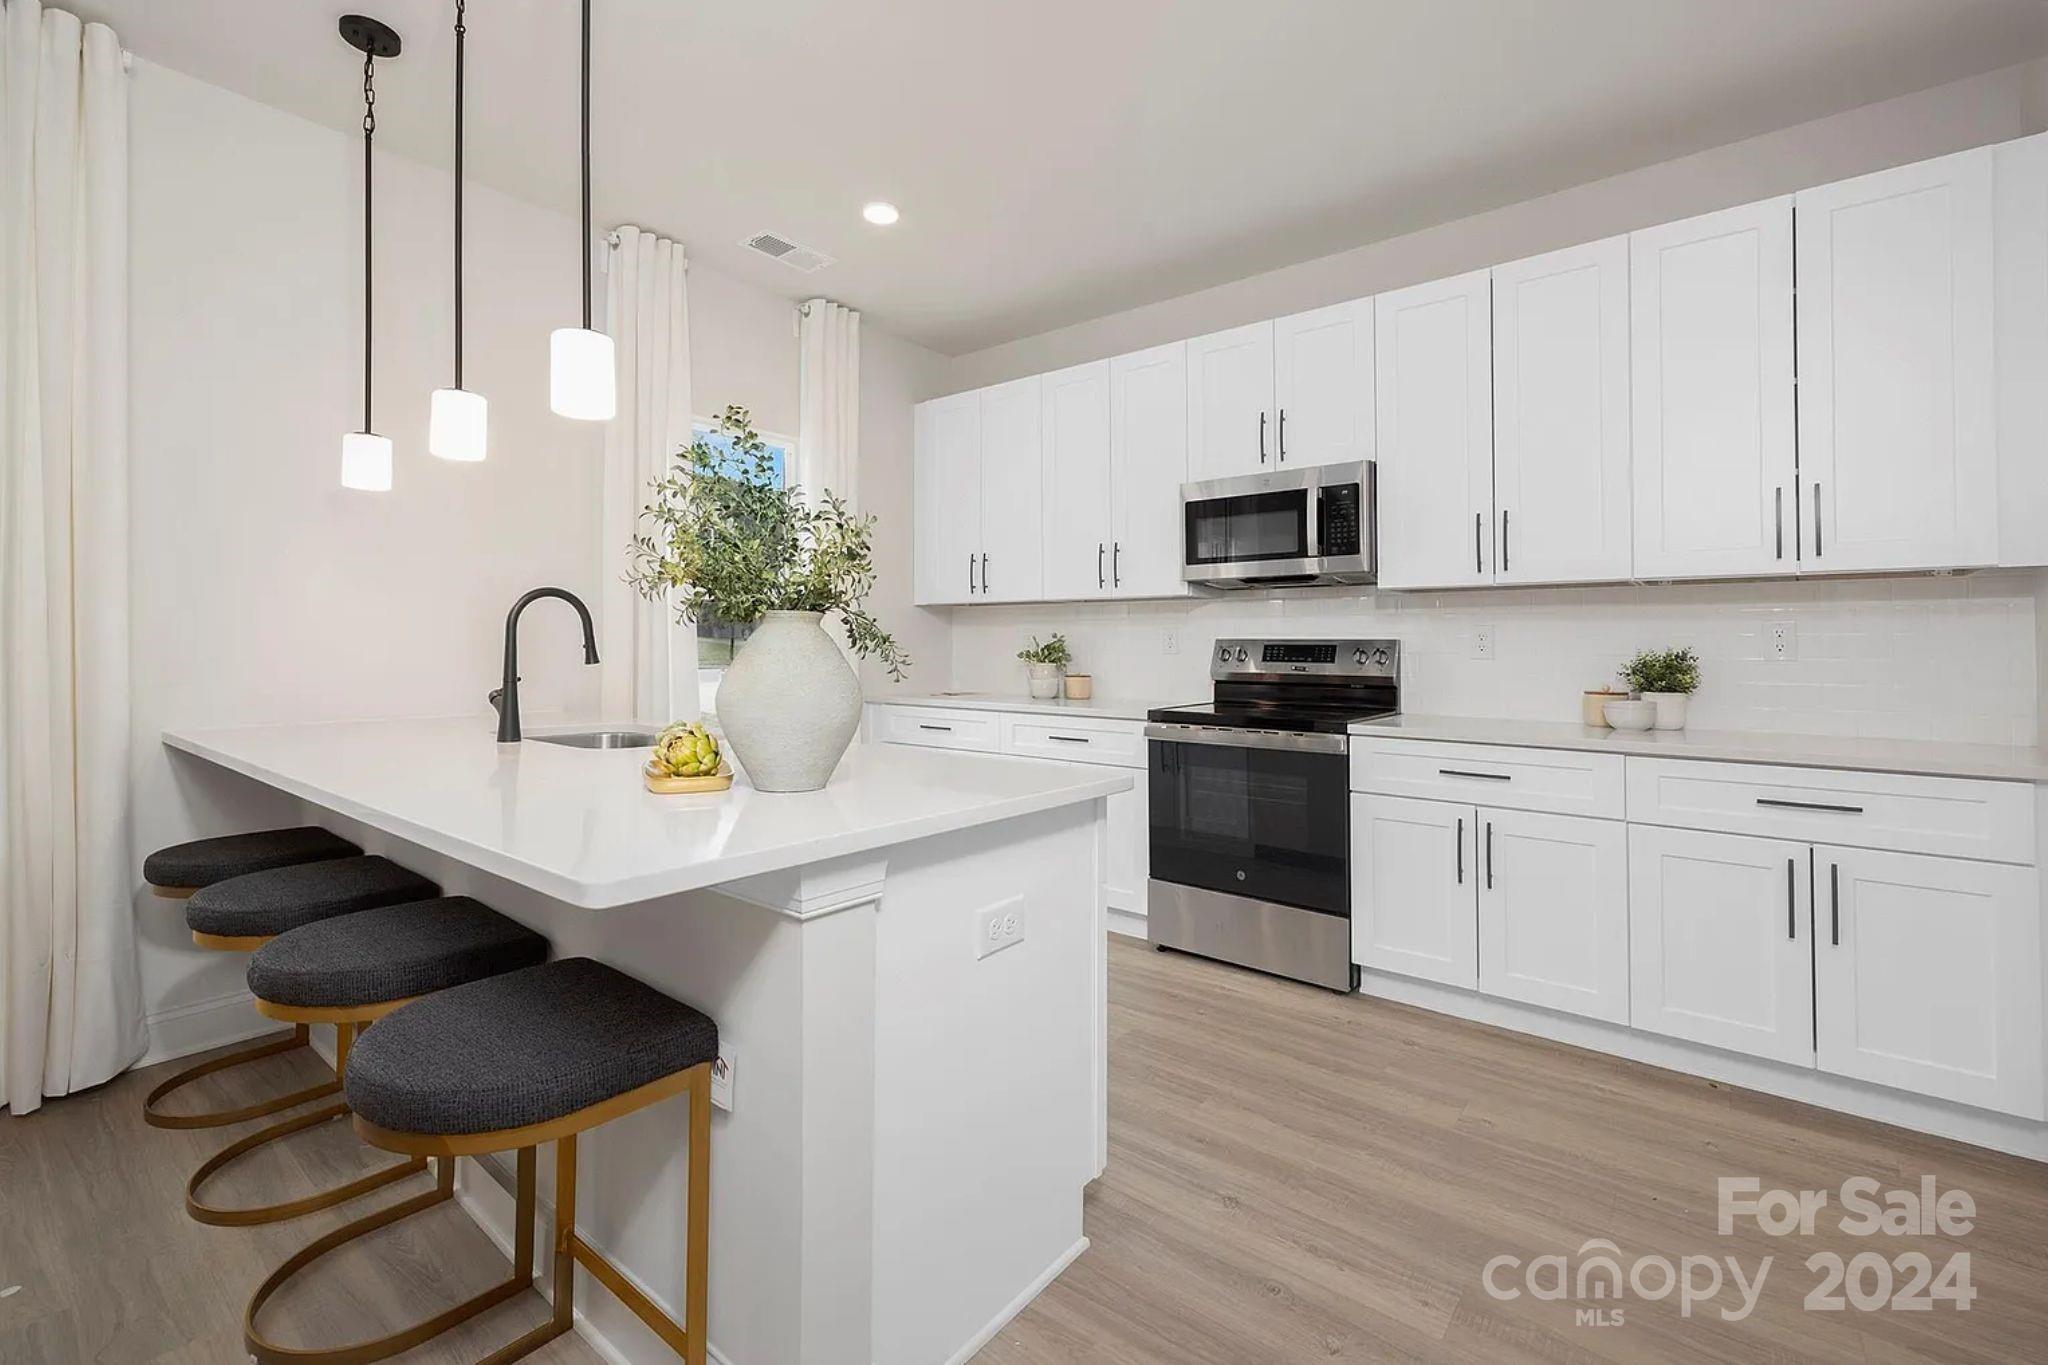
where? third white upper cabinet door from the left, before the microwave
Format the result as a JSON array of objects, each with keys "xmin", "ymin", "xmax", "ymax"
[{"xmin": 1040, "ymin": 360, "xmax": 1116, "ymax": 602}]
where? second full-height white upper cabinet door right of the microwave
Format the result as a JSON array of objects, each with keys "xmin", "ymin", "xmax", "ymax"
[{"xmin": 1493, "ymin": 237, "xmax": 1630, "ymax": 583}]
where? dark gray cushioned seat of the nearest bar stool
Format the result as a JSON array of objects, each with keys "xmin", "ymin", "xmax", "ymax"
[{"xmin": 348, "ymin": 958, "xmax": 719, "ymax": 1136}]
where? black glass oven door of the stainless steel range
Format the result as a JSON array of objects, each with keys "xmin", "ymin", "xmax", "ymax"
[{"xmin": 1145, "ymin": 724, "xmax": 1352, "ymax": 919}]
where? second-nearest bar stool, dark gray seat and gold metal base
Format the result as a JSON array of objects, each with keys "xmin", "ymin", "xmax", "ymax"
[{"xmin": 184, "ymin": 896, "xmax": 547, "ymax": 1226}]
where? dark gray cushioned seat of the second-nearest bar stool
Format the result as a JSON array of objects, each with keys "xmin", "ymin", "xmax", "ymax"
[{"xmin": 250, "ymin": 896, "xmax": 547, "ymax": 1009}]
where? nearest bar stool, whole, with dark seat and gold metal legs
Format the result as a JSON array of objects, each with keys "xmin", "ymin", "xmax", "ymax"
[{"xmin": 242, "ymin": 958, "xmax": 719, "ymax": 1365}]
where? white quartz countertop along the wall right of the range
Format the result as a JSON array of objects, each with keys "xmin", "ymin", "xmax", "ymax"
[{"xmin": 1352, "ymin": 714, "xmax": 2048, "ymax": 782}]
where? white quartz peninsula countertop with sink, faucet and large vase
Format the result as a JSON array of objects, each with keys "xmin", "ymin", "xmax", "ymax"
[{"xmin": 164, "ymin": 716, "xmax": 1130, "ymax": 909}]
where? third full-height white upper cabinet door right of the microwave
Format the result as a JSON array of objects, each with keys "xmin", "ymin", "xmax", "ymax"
[{"xmin": 1628, "ymin": 196, "xmax": 1798, "ymax": 579}]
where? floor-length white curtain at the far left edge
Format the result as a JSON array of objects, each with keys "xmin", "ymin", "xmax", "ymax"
[{"xmin": 0, "ymin": 0, "xmax": 145, "ymax": 1113}]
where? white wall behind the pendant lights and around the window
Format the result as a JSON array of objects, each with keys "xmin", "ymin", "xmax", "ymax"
[{"xmin": 131, "ymin": 59, "xmax": 948, "ymax": 1054}]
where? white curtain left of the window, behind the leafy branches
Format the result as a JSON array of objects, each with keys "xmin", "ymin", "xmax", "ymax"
[{"xmin": 602, "ymin": 227, "xmax": 698, "ymax": 724}]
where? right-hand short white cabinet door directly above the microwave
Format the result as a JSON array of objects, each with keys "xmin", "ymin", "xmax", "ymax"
[{"xmin": 1274, "ymin": 299, "xmax": 1374, "ymax": 465}]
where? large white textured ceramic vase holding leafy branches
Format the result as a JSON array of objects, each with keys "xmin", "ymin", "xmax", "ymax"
[{"xmin": 719, "ymin": 612, "xmax": 860, "ymax": 792}]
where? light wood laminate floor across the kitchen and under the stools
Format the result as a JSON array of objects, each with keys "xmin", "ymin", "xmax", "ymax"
[{"xmin": 0, "ymin": 939, "xmax": 2048, "ymax": 1365}]
